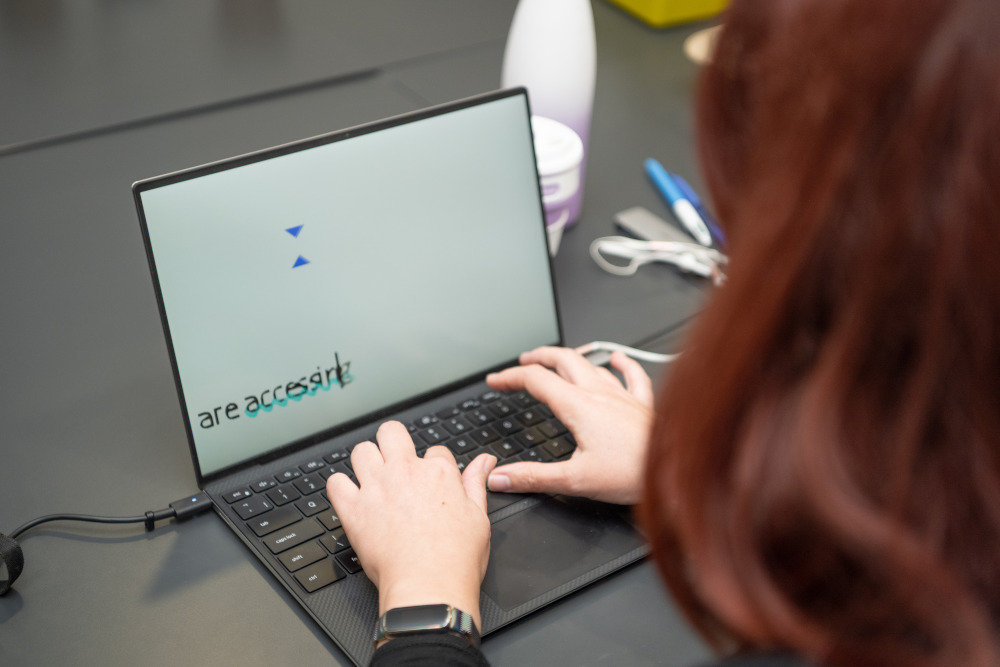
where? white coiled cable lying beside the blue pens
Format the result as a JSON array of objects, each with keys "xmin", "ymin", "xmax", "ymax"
[{"xmin": 590, "ymin": 236, "xmax": 727, "ymax": 285}]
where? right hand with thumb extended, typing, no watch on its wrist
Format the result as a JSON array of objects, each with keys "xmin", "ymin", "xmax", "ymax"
[{"xmin": 486, "ymin": 347, "xmax": 654, "ymax": 505}]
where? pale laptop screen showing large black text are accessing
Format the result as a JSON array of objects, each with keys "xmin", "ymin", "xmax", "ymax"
[{"xmin": 134, "ymin": 91, "xmax": 560, "ymax": 476}]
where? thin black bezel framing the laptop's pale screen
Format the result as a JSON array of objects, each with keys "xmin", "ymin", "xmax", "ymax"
[{"xmin": 132, "ymin": 88, "xmax": 563, "ymax": 488}]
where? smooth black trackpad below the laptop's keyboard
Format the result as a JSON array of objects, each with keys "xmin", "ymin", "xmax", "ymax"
[{"xmin": 483, "ymin": 496, "xmax": 643, "ymax": 611}]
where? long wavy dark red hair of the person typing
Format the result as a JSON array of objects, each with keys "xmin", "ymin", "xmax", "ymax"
[{"xmin": 640, "ymin": 0, "xmax": 1000, "ymax": 666}]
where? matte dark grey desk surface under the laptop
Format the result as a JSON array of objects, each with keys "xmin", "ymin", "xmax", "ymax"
[{"xmin": 0, "ymin": 0, "xmax": 720, "ymax": 665}]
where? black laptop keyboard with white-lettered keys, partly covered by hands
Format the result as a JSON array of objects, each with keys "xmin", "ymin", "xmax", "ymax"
[{"xmin": 224, "ymin": 391, "xmax": 576, "ymax": 593}]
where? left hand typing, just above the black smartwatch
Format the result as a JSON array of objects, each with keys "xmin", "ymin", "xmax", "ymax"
[{"xmin": 326, "ymin": 422, "xmax": 496, "ymax": 629}]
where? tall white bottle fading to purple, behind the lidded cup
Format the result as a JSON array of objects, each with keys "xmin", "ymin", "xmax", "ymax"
[{"xmin": 500, "ymin": 0, "xmax": 597, "ymax": 224}]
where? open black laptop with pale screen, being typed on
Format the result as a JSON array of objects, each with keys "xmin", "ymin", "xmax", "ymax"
[{"xmin": 133, "ymin": 89, "xmax": 647, "ymax": 664}]
